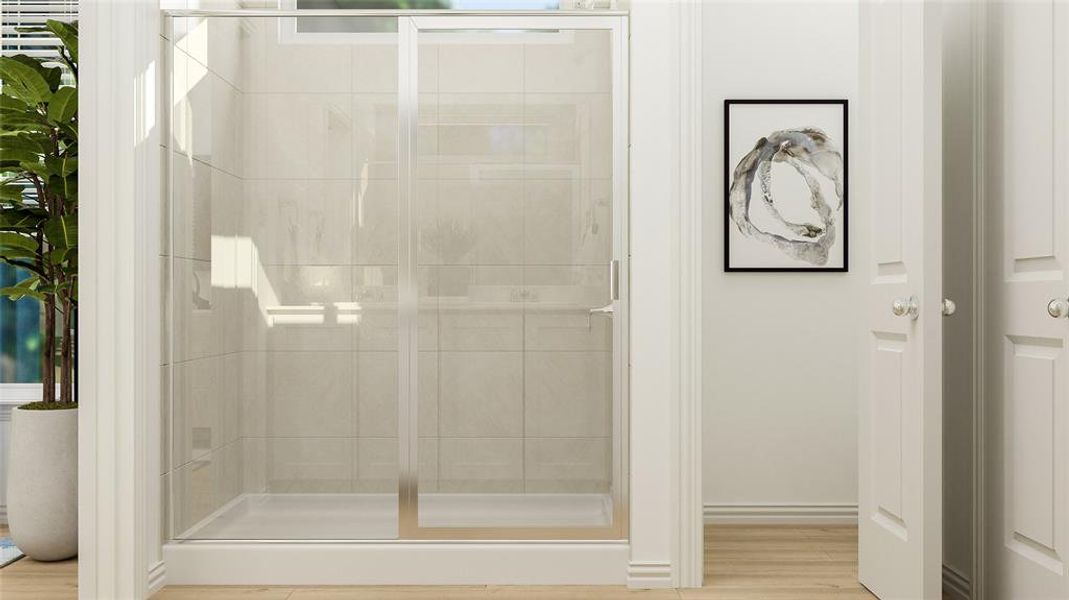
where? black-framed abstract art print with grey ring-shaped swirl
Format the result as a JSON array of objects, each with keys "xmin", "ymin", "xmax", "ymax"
[{"xmin": 724, "ymin": 99, "xmax": 849, "ymax": 272}]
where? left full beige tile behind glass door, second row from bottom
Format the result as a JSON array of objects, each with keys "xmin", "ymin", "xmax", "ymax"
[{"xmin": 438, "ymin": 352, "xmax": 524, "ymax": 437}]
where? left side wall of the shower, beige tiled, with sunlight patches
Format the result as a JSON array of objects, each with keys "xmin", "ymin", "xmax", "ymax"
[{"xmin": 161, "ymin": 8, "xmax": 250, "ymax": 532}]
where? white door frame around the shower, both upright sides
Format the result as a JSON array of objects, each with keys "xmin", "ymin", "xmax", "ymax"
[{"xmin": 78, "ymin": 0, "xmax": 702, "ymax": 600}]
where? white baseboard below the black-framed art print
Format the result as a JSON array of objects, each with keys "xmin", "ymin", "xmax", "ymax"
[{"xmin": 704, "ymin": 504, "xmax": 857, "ymax": 525}]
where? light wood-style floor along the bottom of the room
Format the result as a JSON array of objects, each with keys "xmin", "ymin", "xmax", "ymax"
[{"xmin": 0, "ymin": 525, "xmax": 874, "ymax": 600}]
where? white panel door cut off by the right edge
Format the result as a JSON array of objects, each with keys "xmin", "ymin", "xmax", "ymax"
[{"xmin": 986, "ymin": 0, "xmax": 1069, "ymax": 600}]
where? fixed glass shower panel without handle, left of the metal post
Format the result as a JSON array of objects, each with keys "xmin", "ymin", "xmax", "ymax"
[{"xmin": 164, "ymin": 16, "xmax": 399, "ymax": 539}]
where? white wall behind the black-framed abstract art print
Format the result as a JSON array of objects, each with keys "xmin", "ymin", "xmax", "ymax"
[{"xmin": 703, "ymin": 0, "xmax": 867, "ymax": 513}]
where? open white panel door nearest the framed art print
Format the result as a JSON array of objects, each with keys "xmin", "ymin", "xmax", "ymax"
[{"xmin": 858, "ymin": 0, "xmax": 943, "ymax": 600}]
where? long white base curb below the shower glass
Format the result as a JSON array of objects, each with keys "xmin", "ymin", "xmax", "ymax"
[{"xmin": 164, "ymin": 541, "xmax": 628, "ymax": 586}]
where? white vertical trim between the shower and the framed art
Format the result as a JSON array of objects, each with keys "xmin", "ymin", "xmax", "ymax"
[{"xmin": 629, "ymin": 0, "xmax": 702, "ymax": 587}]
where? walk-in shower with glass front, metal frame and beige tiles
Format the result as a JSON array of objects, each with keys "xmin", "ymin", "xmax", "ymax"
[{"xmin": 161, "ymin": 10, "xmax": 628, "ymax": 541}]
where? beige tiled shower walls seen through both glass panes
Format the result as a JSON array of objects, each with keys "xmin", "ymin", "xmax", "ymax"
[{"xmin": 162, "ymin": 18, "xmax": 613, "ymax": 530}]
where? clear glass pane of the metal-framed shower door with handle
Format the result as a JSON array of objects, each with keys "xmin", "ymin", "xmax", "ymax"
[{"xmin": 413, "ymin": 29, "xmax": 618, "ymax": 528}]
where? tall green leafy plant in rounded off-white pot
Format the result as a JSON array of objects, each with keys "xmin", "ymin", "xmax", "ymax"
[{"xmin": 0, "ymin": 20, "xmax": 78, "ymax": 560}]
